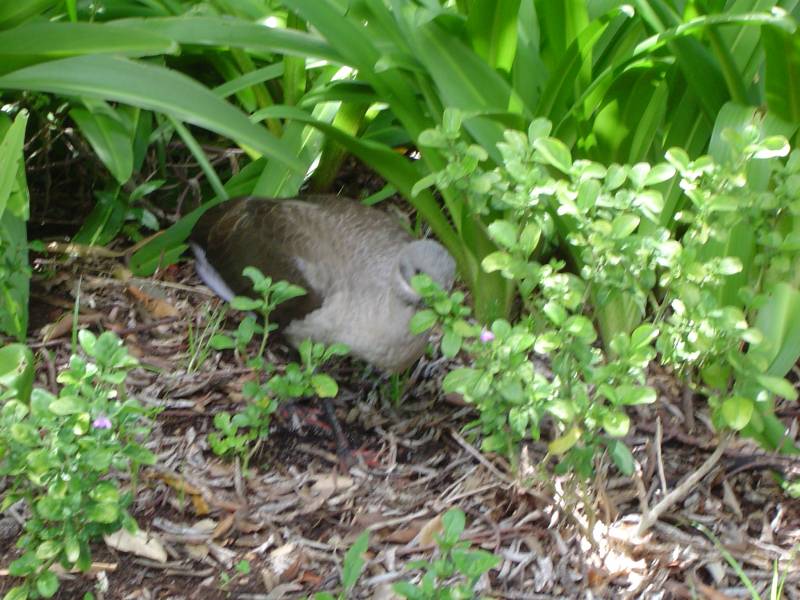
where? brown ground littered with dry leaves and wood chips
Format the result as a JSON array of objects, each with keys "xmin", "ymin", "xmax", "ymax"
[{"xmin": 0, "ymin": 135, "xmax": 800, "ymax": 600}]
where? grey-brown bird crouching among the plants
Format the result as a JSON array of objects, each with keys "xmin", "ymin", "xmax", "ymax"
[{"xmin": 190, "ymin": 196, "xmax": 455, "ymax": 372}]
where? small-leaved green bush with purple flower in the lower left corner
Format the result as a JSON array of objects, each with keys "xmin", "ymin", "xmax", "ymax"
[{"xmin": 0, "ymin": 330, "xmax": 155, "ymax": 600}]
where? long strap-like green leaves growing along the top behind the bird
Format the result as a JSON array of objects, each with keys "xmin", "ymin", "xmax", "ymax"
[{"xmin": 0, "ymin": 0, "xmax": 800, "ymax": 330}]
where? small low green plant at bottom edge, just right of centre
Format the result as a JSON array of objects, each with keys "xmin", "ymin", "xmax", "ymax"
[{"xmin": 392, "ymin": 508, "xmax": 500, "ymax": 600}]
